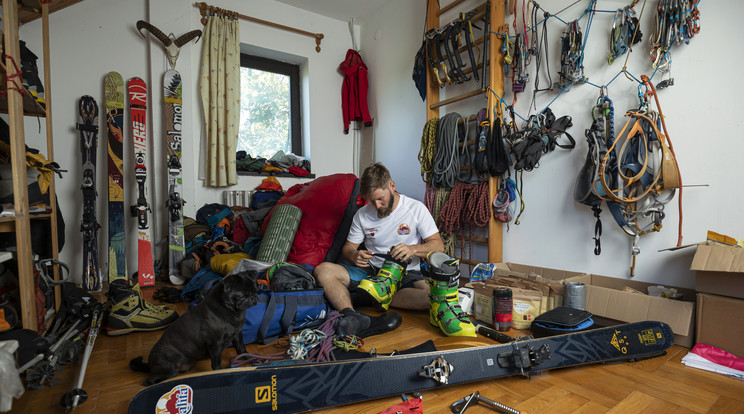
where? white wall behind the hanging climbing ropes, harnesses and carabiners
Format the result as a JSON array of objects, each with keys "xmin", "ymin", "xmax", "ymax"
[{"xmin": 362, "ymin": 0, "xmax": 744, "ymax": 287}]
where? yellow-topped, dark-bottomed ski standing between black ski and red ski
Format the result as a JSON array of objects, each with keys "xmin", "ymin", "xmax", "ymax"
[{"xmin": 103, "ymin": 72, "xmax": 127, "ymax": 283}]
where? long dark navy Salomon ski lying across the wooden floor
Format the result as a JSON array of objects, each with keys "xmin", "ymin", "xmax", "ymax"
[{"xmin": 129, "ymin": 321, "xmax": 674, "ymax": 414}]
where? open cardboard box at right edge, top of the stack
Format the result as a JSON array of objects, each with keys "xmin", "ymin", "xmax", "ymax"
[{"xmin": 690, "ymin": 244, "xmax": 744, "ymax": 299}]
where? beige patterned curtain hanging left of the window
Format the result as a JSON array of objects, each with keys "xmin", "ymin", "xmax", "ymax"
[{"xmin": 199, "ymin": 14, "xmax": 240, "ymax": 187}]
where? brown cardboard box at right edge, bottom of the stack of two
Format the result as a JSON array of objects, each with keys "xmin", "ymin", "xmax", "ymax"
[{"xmin": 695, "ymin": 292, "xmax": 744, "ymax": 358}]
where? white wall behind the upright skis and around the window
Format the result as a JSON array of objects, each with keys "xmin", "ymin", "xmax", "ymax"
[{"xmin": 21, "ymin": 0, "xmax": 352, "ymax": 281}]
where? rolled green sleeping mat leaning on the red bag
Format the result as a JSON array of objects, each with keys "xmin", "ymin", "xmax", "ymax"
[{"xmin": 256, "ymin": 204, "xmax": 302, "ymax": 263}]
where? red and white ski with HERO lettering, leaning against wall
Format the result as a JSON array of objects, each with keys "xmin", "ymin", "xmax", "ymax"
[{"xmin": 127, "ymin": 78, "xmax": 155, "ymax": 287}]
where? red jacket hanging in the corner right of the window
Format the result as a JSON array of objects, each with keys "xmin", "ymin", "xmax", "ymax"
[{"xmin": 338, "ymin": 49, "xmax": 372, "ymax": 134}]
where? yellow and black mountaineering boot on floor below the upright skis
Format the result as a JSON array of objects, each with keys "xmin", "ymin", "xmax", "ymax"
[{"xmin": 106, "ymin": 279, "xmax": 178, "ymax": 336}]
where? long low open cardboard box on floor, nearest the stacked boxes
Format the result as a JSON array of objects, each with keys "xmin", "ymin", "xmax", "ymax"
[{"xmin": 566, "ymin": 275, "xmax": 695, "ymax": 348}]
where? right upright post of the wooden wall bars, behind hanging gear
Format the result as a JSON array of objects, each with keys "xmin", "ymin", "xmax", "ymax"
[{"xmin": 488, "ymin": 0, "xmax": 505, "ymax": 263}]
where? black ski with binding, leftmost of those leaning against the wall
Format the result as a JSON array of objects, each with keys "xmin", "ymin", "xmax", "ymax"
[{"xmin": 76, "ymin": 95, "xmax": 103, "ymax": 292}]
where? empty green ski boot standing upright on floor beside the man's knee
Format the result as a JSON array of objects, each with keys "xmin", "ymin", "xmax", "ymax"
[{"xmin": 427, "ymin": 252, "xmax": 476, "ymax": 336}]
